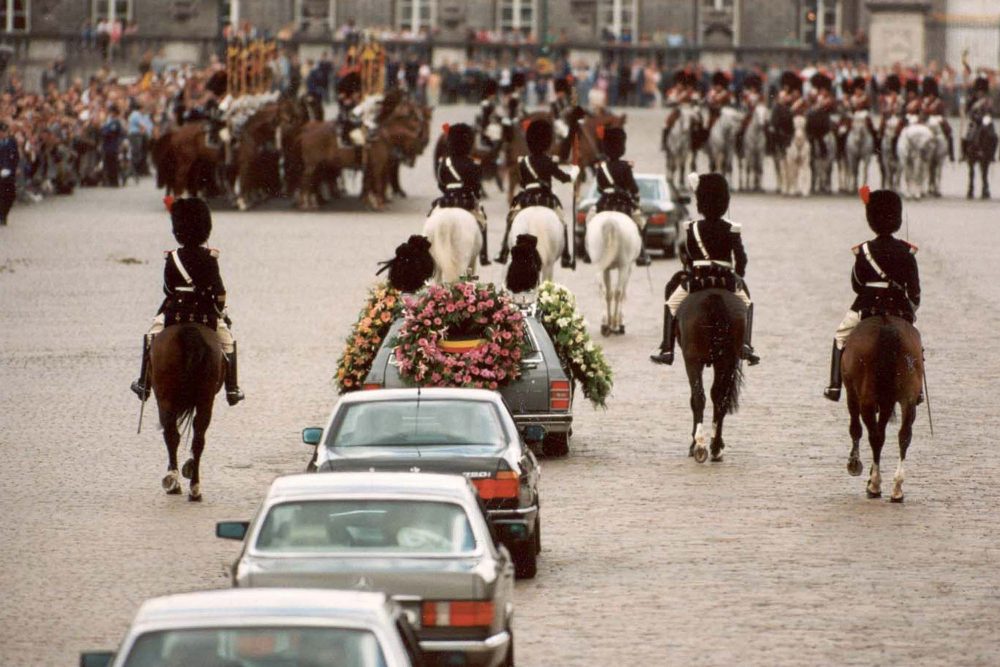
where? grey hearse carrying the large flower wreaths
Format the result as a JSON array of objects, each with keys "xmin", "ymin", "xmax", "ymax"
[{"xmin": 364, "ymin": 313, "xmax": 573, "ymax": 456}]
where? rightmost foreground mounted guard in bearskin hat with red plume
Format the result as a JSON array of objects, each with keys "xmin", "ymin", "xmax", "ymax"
[{"xmin": 823, "ymin": 188, "xmax": 920, "ymax": 401}]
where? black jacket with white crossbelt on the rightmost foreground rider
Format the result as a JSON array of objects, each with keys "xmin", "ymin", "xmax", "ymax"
[{"xmin": 851, "ymin": 236, "xmax": 920, "ymax": 322}]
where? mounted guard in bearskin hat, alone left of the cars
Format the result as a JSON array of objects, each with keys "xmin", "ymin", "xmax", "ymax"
[{"xmin": 132, "ymin": 197, "xmax": 244, "ymax": 405}]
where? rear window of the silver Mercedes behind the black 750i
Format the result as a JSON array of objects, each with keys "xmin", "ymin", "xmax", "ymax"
[{"xmin": 256, "ymin": 500, "xmax": 476, "ymax": 555}]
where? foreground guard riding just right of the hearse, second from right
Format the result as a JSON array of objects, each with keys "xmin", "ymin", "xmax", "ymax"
[{"xmin": 650, "ymin": 173, "xmax": 760, "ymax": 366}]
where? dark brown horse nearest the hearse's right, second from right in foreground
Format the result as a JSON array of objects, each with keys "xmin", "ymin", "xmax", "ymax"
[{"xmin": 677, "ymin": 288, "xmax": 747, "ymax": 463}]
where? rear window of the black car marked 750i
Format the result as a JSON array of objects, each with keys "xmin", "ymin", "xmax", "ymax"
[{"xmin": 326, "ymin": 400, "xmax": 505, "ymax": 447}]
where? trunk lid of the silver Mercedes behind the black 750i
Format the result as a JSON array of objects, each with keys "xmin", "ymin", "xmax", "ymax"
[{"xmin": 239, "ymin": 554, "xmax": 493, "ymax": 600}]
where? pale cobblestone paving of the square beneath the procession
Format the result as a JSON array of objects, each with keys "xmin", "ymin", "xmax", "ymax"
[{"xmin": 0, "ymin": 107, "xmax": 1000, "ymax": 667}]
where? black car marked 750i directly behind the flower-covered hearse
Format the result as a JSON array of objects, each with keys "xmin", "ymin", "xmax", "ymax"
[{"xmin": 302, "ymin": 388, "xmax": 544, "ymax": 578}]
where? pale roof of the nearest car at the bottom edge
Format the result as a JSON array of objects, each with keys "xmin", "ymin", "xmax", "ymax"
[{"xmin": 133, "ymin": 588, "xmax": 388, "ymax": 630}]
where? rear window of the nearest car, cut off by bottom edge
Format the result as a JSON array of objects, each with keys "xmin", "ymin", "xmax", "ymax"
[{"xmin": 125, "ymin": 627, "xmax": 386, "ymax": 667}]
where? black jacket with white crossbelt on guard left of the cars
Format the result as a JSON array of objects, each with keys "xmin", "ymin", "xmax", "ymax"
[{"xmin": 159, "ymin": 246, "xmax": 226, "ymax": 329}]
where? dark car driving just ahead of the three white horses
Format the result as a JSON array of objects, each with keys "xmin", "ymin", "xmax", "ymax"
[{"xmin": 575, "ymin": 174, "xmax": 691, "ymax": 257}]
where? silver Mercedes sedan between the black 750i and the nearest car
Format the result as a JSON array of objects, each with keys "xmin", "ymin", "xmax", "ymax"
[{"xmin": 216, "ymin": 473, "xmax": 514, "ymax": 667}]
